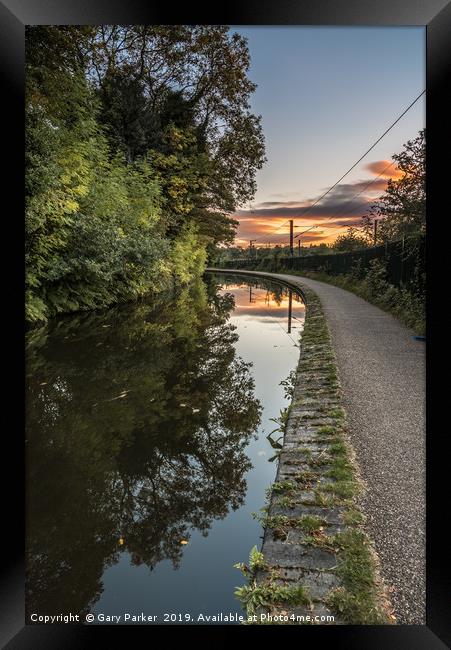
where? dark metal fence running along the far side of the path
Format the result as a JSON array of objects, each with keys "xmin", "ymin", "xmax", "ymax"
[{"xmin": 221, "ymin": 237, "xmax": 426, "ymax": 289}]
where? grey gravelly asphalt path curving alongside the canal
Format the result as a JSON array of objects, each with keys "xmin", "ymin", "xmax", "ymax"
[{"xmin": 212, "ymin": 269, "xmax": 426, "ymax": 625}]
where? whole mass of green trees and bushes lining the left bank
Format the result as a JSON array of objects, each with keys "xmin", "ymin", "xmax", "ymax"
[{"xmin": 26, "ymin": 26, "xmax": 264, "ymax": 322}]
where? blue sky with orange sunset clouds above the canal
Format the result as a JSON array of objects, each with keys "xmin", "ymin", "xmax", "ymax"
[{"xmin": 230, "ymin": 26, "xmax": 426, "ymax": 246}]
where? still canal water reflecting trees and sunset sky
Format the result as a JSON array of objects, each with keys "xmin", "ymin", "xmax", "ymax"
[{"xmin": 26, "ymin": 274, "xmax": 304, "ymax": 625}]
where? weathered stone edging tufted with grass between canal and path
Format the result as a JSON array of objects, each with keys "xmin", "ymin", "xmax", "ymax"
[{"xmin": 230, "ymin": 271, "xmax": 395, "ymax": 625}]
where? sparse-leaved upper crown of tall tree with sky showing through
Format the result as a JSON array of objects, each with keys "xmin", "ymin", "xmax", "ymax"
[{"xmin": 85, "ymin": 25, "xmax": 265, "ymax": 227}]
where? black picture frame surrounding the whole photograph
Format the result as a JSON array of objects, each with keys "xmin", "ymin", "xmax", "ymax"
[{"xmin": 0, "ymin": 0, "xmax": 451, "ymax": 650}]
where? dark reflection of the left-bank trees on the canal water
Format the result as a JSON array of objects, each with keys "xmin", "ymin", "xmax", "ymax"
[{"xmin": 27, "ymin": 284, "xmax": 261, "ymax": 614}]
